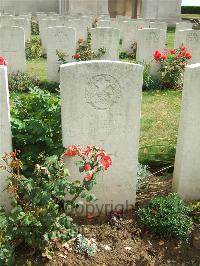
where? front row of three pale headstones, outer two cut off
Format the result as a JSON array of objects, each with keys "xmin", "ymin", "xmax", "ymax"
[{"xmin": 0, "ymin": 61, "xmax": 200, "ymax": 214}]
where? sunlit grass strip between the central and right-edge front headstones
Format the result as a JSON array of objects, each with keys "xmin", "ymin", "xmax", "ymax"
[{"xmin": 139, "ymin": 90, "xmax": 181, "ymax": 165}]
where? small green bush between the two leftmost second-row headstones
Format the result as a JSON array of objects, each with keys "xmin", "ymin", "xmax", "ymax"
[{"xmin": 25, "ymin": 36, "xmax": 42, "ymax": 60}]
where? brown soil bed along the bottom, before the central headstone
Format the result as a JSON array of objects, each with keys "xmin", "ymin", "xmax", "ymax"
[{"xmin": 15, "ymin": 177, "xmax": 200, "ymax": 266}]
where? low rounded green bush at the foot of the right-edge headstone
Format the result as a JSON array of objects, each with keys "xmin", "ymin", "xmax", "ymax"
[{"xmin": 137, "ymin": 194, "xmax": 192, "ymax": 241}]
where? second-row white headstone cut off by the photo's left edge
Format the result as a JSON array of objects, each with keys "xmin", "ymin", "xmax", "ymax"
[{"xmin": 0, "ymin": 27, "xmax": 26, "ymax": 73}]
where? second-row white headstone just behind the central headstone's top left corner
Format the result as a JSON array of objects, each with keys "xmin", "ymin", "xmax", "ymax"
[{"xmin": 47, "ymin": 26, "xmax": 76, "ymax": 82}]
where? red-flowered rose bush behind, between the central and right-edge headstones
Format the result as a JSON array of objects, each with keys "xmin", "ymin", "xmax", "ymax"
[{"xmin": 154, "ymin": 46, "xmax": 192, "ymax": 89}]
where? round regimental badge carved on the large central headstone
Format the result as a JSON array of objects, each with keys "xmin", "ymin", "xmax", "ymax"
[{"xmin": 85, "ymin": 74, "xmax": 121, "ymax": 110}]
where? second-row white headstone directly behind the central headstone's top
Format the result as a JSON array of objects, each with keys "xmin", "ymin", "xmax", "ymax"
[{"xmin": 91, "ymin": 28, "xmax": 120, "ymax": 60}]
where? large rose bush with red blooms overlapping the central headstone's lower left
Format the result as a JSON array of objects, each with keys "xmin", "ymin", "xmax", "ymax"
[{"xmin": 0, "ymin": 145, "xmax": 112, "ymax": 265}]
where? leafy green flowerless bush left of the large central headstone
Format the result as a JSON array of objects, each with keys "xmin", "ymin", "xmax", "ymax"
[{"xmin": 11, "ymin": 88, "xmax": 63, "ymax": 169}]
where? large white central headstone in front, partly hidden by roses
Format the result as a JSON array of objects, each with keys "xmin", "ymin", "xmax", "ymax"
[{"xmin": 61, "ymin": 61, "xmax": 143, "ymax": 214}]
